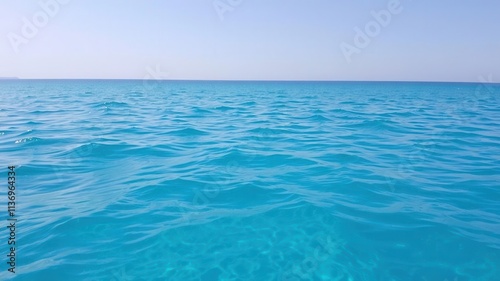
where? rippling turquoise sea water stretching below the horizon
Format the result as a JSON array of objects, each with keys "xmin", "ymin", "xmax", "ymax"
[{"xmin": 0, "ymin": 80, "xmax": 500, "ymax": 281}]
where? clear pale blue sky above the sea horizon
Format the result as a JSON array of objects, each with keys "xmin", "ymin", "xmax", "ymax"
[{"xmin": 0, "ymin": 0, "xmax": 500, "ymax": 82}]
